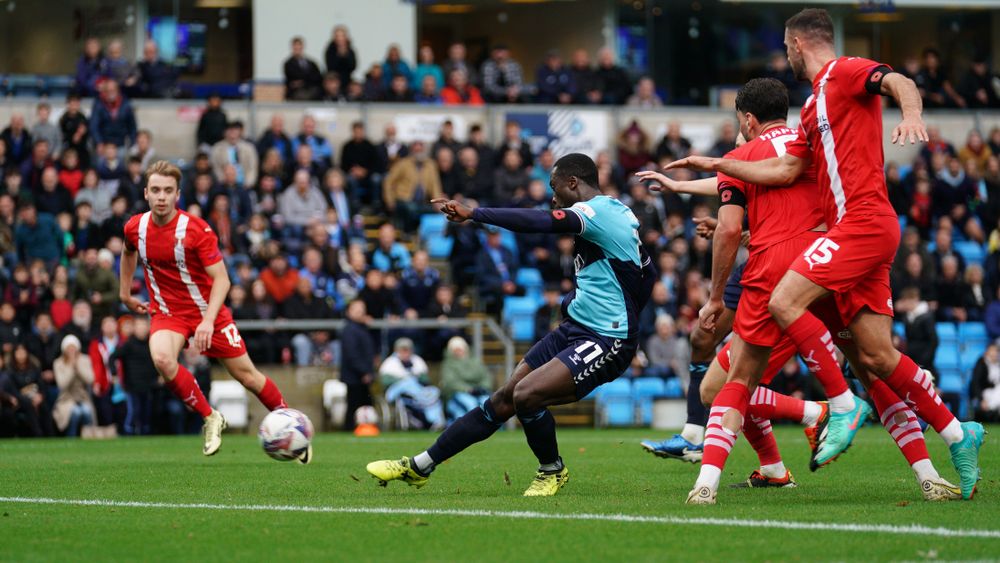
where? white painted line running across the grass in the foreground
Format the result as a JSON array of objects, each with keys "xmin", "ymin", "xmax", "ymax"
[{"xmin": 0, "ymin": 497, "xmax": 1000, "ymax": 539}]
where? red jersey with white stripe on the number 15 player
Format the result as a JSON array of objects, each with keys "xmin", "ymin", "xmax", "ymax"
[{"xmin": 787, "ymin": 57, "xmax": 896, "ymax": 227}]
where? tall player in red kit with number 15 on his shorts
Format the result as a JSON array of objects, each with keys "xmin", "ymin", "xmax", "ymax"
[{"xmin": 667, "ymin": 9, "xmax": 984, "ymax": 499}]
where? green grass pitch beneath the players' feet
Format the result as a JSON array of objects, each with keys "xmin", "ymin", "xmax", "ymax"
[{"xmin": 0, "ymin": 427, "xmax": 1000, "ymax": 561}]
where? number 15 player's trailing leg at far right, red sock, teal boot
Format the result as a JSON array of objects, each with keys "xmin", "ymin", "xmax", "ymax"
[{"xmin": 850, "ymin": 309, "xmax": 985, "ymax": 499}]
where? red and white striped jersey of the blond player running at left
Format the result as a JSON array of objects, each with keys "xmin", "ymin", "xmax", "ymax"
[{"xmin": 125, "ymin": 210, "xmax": 222, "ymax": 319}]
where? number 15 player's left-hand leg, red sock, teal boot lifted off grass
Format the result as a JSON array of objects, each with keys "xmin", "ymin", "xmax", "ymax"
[{"xmin": 768, "ymin": 268, "xmax": 871, "ymax": 471}]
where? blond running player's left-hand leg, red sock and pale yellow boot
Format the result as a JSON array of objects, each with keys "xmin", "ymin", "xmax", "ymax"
[{"xmin": 149, "ymin": 330, "xmax": 226, "ymax": 455}]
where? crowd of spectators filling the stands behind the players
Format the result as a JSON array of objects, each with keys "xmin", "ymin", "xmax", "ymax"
[{"xmin": 0, "ymin": 33, "xmax": 1000, "ymax": 436}]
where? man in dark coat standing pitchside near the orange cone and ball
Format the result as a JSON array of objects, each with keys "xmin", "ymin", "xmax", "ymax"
[{"xmin": 340, "ymin": 299, "xmax": 375, "ymax": 431}]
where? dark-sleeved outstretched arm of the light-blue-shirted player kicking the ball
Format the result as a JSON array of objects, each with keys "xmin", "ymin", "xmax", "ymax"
[{"xmin": 431, "ymin": 199, "xmax": 583, "ymax": 234}]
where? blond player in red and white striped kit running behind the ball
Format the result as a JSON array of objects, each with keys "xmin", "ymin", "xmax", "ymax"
[{"xmin": 120, "ymin": 161, "xmax": 296, "ymax": 463}]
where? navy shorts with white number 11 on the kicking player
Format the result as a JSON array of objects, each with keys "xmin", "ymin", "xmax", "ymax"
[{"xmin": 524, "ymin": 319, "xmax": 638, "ymax": 399}]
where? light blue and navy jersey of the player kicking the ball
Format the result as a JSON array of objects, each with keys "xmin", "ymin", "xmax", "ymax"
[{"xmin": 567, "ymin": 196, "xmax": 651, "ymax": 338}]
